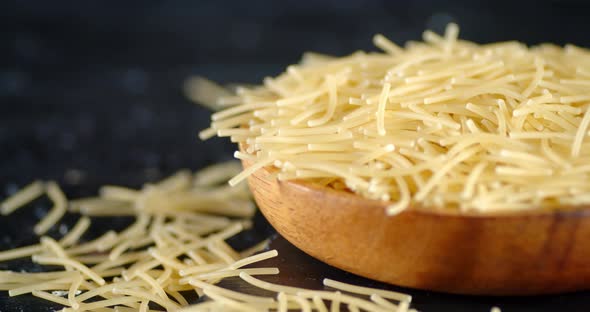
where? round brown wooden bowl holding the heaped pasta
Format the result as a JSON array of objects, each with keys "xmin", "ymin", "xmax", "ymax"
[{"xmin": 244, "ymin": 162, "xmax": 590, "ymax": 295}]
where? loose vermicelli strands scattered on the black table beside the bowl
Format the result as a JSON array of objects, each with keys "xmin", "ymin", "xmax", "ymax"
[{"xmin": 0, "ymin": 162, "xmax": 418, "ymax": 312}]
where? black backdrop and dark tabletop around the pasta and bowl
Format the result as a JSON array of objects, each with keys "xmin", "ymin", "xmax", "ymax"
[{"xmin": 0, "ymin": 0, "xmax": 590, "ymax": 312}]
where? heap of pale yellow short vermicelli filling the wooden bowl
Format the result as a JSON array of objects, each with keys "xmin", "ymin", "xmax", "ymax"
[{"xmin": 193, "ymin": 24, "xmax": 590, "ymax": 215}]
